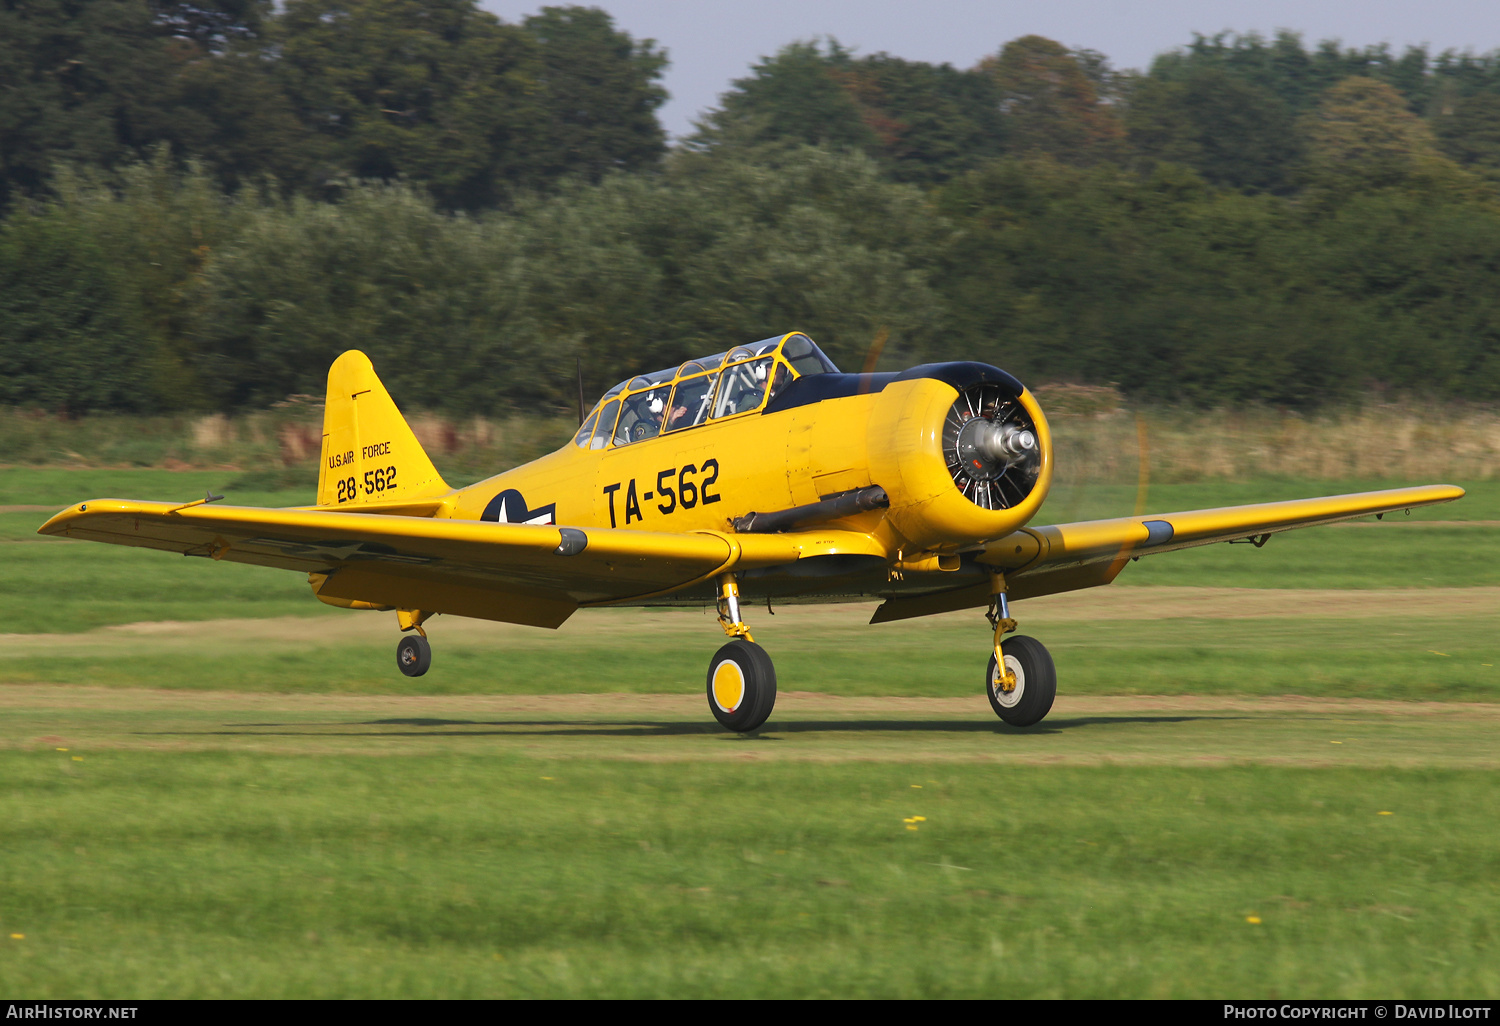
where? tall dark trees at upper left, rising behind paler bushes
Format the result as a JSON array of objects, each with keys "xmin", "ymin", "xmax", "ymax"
[{"xmin": 0, "ymin": 0, "xmax": 666, "ymax": 210}]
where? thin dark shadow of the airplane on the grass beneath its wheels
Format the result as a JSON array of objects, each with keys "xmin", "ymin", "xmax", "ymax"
[{"xmin": 141, "ymin": 716, "xmax": 1230, "ymax": 741}]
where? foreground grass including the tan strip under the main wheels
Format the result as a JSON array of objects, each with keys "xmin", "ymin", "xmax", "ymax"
[{"xmin": 0, "ymin": 687, "xmax": 1500, "ymax": 998}]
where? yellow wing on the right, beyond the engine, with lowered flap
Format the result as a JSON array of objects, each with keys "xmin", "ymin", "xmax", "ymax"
[{"xmin": 872, "ymin": 485, "xmax": 1464, "ymax": 623}]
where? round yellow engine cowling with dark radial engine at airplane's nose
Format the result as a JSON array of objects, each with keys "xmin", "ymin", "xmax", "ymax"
[{"xmin": 867, "ymin": 363, "xmax": 1052, "ymax": 552}]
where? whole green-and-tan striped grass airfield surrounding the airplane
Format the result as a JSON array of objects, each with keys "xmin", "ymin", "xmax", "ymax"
[{"xmin": 0, "ymin": 470, "xmax": 1500, "ymax": 999}]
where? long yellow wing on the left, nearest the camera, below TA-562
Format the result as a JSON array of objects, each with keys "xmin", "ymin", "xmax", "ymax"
[{"xmin": 39, "ymin": 498, "xmax": 882, "ymax": 627}]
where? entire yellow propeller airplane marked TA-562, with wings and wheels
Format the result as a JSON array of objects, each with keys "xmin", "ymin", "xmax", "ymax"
[{"xmin": 41, "ymin": 332, "xmax": 1464, "ymax": 731}]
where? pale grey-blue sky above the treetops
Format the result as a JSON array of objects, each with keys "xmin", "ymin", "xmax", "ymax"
[{"xmin": 480, "ymin": 0, "xmax": 1500, "ymax": 137}]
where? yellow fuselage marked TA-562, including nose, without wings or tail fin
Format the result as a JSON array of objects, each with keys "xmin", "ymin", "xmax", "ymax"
[{"xmin": 449, "ymin": 336, "xmax": 1052, "ymax": 606}]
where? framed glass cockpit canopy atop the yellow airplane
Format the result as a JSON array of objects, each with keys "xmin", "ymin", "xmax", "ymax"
[{"xmin": 573, "ymin": 332, "xmax": 839, "ymax": 449}]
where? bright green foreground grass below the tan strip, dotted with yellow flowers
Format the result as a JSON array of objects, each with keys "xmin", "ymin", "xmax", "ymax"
[{"xmin": 0, "ymin": 750, "xmax": 1500, "ymax": 999}]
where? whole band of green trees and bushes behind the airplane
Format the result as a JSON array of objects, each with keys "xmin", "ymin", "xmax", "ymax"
[{"xmin": 0, "ymin": 0, "xmax": 1500, "ymax": 413}]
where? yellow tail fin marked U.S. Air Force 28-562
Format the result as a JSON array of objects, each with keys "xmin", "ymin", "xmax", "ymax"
[{"xmin": 318, "ymin": 350, "xmax": 452, "ymax": 516}]
